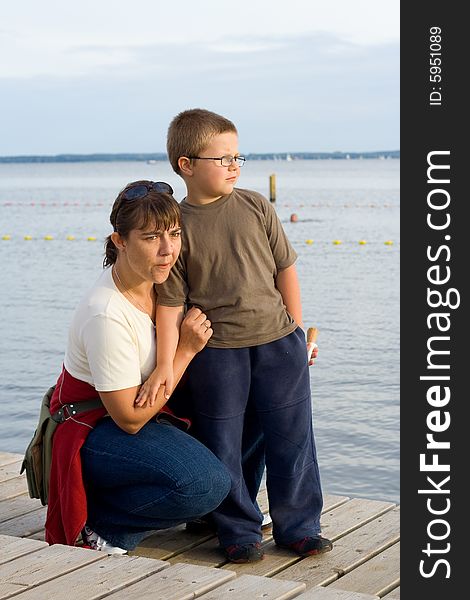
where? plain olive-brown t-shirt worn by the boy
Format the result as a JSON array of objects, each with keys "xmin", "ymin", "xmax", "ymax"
[{"xmin": 156, "ymin": 188, "xmax": 297, "ymax": 348}]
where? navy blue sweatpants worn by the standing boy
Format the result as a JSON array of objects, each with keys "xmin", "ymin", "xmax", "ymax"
[{"xmin": 188, "ymin": 328, "xmax": 323, "ymax": 547}]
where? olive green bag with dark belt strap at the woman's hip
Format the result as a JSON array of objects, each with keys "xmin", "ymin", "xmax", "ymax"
[{"xmin": 20, "ymin": 385, "xmax": 103, "ymax": 506}]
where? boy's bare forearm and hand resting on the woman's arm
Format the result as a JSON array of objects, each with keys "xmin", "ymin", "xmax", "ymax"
[{"xmin": 135, "ymin": 305, "xmax": 184, "ymax": 406}]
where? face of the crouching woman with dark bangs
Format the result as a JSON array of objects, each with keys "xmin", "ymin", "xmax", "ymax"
[{"xmin": 120, "ymin": 225, "xmax": 181, "ymax": 283}]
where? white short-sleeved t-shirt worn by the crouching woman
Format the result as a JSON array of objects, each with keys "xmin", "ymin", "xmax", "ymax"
[{"xmin": 64, "ymin": 268, "xmax": 156, "ymax": 392}]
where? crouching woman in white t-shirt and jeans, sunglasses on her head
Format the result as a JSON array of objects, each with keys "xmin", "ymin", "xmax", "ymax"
[{"xmin": 46, "ymin": 181, "xmax": 230, "ymax": 554}]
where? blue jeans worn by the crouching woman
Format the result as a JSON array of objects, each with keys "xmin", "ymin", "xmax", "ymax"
[{"xmin": 81, "ymin": 417, "xmax": 230, "ymax": 550}]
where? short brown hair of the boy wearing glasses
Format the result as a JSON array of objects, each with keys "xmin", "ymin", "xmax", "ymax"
[{"xmin": 166, "ymin": 108, "xmax": 238, "ymax": 175}]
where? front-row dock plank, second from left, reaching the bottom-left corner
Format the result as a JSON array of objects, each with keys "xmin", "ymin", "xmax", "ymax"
[{"xmin": 0, "ymin": 544, "xmax": 107, "ymax": 598}]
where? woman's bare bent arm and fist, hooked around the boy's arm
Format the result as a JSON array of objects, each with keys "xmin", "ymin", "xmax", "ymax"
[{"xmin": 99, "ymin": 308, "xmax": 213, "ymax": 434}]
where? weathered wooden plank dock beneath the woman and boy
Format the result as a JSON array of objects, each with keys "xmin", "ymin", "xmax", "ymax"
[{"xmin": 0, "ymin": 452, "xmax": 400, "ymax": 600}]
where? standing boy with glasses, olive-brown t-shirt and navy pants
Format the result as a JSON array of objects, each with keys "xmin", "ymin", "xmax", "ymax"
[{"xmin": 141, "ymin": 109, "xmax": 332, "ymax": 562}]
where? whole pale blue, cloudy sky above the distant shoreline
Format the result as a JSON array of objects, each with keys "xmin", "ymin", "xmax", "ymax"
[{"xmin": 0, "ymin": 0, "xmax": 400, "ymax": 156}]
